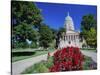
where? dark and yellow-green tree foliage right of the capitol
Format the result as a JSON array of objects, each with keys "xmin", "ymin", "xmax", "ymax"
[{"xmin": 81, "ymin": 14, "xmax": 97, "ymax": 47}]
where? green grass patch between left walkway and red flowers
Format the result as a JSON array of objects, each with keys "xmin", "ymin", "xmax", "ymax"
[{"xmin": 22, "ymin": 57, "xmax": 53, "ymax": 74}]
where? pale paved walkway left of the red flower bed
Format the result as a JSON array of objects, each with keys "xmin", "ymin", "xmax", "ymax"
[{"xmin": 12, "ymin": 52, "xmax": 54, "ymax": 75}]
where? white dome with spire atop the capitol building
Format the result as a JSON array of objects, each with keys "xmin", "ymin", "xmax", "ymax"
[{"xmin": 65, "ymin": 13, "xmax": 74, "ymax": 31}]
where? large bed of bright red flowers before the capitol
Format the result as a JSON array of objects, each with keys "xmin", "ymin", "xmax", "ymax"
[{"xmin": 49, "ymin": 47, "xmax": 84, "ymax": 72}]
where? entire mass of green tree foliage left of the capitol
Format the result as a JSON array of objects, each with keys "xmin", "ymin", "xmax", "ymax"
[{"xmin": 11, "ymin": 1, "xmax": 56, "ymax": 48}]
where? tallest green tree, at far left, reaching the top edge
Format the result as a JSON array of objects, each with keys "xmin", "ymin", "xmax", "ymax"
[{"xmin": 11, "ymin": 1, "xmax": 42, "ymax": 47}]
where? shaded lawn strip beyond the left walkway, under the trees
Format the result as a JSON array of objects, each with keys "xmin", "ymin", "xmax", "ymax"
[{"xmin": 12, "ymin": 49, "xmax": 54, "ymax": 62}]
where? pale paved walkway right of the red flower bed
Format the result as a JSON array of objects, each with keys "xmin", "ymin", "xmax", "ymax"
[{"xmin": 81, "ymin": 50, "xmax": 97, "ymax": 63}]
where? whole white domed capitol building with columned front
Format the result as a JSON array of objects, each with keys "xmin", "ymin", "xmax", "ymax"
[{"xmin": 58, "ymin": 13, "xmax": 82, "ymax": 48}]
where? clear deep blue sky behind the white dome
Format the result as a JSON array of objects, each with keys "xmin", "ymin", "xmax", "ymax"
[{"xmin": 35, "ymin": 2, "xmax": 97, "ymax": 31}]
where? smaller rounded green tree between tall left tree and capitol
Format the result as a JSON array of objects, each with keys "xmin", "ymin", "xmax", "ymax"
[{"xmin": 39, "ymin": 24, "xmax": 53, "ymax": 48}]
